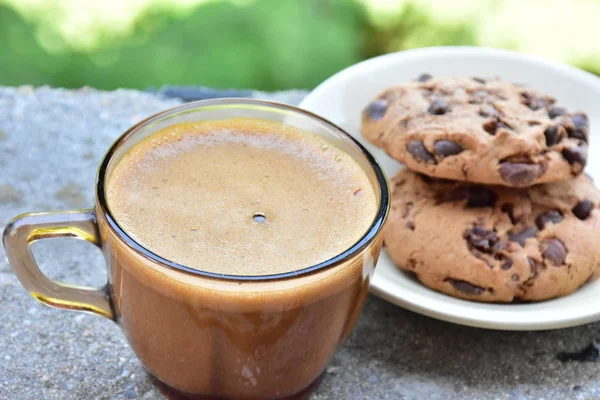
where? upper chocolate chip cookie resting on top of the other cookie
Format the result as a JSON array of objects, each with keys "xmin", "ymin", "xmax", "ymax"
[{"xmin": 362, "ymin": 75, "xmax": 589, "ymax": 187}]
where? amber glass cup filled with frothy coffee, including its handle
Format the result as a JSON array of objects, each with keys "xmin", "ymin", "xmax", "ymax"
[{"xmin": 4, "ymin": 100, "xmax": 388, "ymax": 399}]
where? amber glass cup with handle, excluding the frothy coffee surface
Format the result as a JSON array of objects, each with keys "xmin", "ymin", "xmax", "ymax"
[{"xmin": 3, "ymin": 99, "xmax": 389, "ymax": 399}]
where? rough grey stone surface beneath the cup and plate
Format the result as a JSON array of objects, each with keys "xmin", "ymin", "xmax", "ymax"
[{"xmin": 0, "ymin": 87, "xmax": 600, "ymax": 400}]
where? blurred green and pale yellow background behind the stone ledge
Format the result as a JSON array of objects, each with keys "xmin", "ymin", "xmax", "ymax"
[{"xmin": 0, "ymin": 0, "xmax": 600, "ymax": 90}]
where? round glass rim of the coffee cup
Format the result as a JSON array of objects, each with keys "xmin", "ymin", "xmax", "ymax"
[{"xmin": 96, "ymin": 98, "xmax": 390, "ymax": 281}]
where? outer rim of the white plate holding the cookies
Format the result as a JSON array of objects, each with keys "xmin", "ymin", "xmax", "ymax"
[{"xmin": 298, "ymin": 46, "xmax": 600, "ymax": 331}]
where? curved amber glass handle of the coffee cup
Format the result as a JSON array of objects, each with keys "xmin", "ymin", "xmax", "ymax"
[{"xmin": 3, "ymin": 209, "xmax": 115, "ymax": 320}]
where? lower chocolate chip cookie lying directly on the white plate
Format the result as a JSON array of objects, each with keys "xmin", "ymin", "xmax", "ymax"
[{"xmin": 383, "ymin": 169, "xmax": 600, "ymax": 302}]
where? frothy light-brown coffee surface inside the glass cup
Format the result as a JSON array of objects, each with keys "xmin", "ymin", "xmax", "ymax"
[{"xmin": 107, "ymin": 119, "xmax": 377, "ymax": 275}]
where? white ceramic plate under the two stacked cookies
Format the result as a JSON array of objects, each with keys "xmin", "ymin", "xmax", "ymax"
[{"xmin": 300, "ymin": 47, "xmax": 600, "ymax": 330}]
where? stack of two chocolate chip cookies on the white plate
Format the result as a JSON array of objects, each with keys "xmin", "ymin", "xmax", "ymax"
[{"xmin": 362, "ymin": 74, "xmax": 600, "ymax": 302}]
